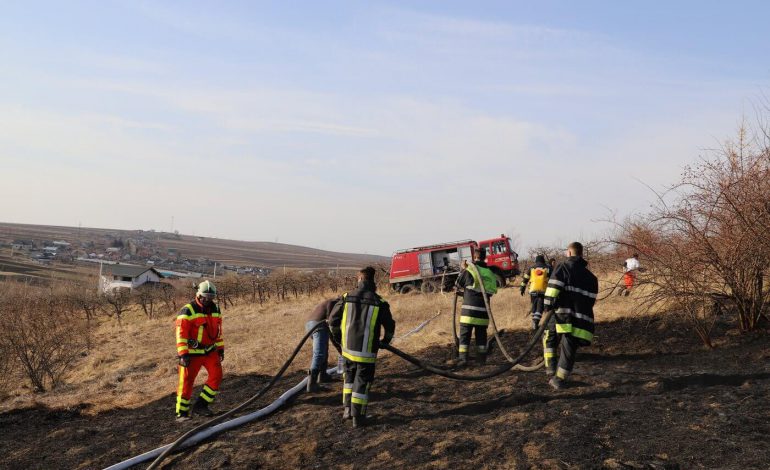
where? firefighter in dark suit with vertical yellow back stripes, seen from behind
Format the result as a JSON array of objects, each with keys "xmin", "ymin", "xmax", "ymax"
[{"xmin": 329, "ymin": 266, "xmax": 396, "ymax": 427}]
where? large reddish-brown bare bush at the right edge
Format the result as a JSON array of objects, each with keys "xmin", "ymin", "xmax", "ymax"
[{"xmin": 616, "ymin": 119, "xmax": 770, "ymax": 346}]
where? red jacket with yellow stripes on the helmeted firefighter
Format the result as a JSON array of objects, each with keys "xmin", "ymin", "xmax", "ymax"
[{"xmin": 176, "ymin": 300, "xmax": 225, "ymax": 356}]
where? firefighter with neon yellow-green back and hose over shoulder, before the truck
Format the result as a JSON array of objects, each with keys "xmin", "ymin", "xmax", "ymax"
[{"xmin": 455, "ymin": 248, "xmax": 497, "ymax": 367}]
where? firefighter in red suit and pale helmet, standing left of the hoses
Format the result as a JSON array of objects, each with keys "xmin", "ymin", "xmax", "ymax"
[{"xmin": 176, "ymin": 281, "xmax": 225, "ymax": 421}]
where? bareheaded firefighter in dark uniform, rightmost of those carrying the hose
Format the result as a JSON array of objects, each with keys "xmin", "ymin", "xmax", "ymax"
[{"xmin": 543, "ymin": 242, "xmax": 599, "ymax": 390}]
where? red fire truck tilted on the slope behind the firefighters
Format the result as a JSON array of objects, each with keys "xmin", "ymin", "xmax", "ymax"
[{"xmin": 390, "ymin": 234, "xmax": 519, "ymax": 293}]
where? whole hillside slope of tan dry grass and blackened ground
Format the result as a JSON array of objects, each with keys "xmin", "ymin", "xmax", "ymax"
[{"xmin": 0, "ymin": 282, "xmax": 770, "ymax": 469}]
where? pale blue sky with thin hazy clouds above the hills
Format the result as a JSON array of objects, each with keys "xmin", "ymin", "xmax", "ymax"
[{"xmin": 0, "ymin": 1, "xmax": 770, "ymax": 255}]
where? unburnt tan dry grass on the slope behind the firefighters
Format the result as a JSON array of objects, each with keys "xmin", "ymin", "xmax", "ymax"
[{"xmin": 0, "ymin": 276, "xmax": 634, "ymax": 413}]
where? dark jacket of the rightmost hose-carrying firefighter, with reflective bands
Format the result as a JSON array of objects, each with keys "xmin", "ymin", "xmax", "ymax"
[{"xmin": 545, "ymin": 256, "xmax": 599, "ymax": 344}]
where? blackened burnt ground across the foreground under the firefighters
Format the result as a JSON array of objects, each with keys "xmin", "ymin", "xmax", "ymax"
[{"xmin": 0, "ymin": 317, "xmax": 770, "ymax": 469}]
